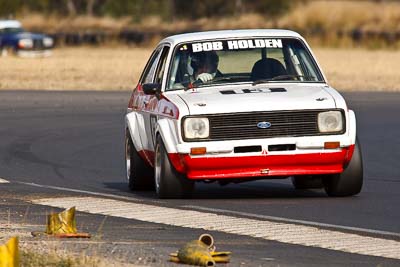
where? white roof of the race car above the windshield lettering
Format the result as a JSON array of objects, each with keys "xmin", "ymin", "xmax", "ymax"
[{"xmin": 160, "ymin": 29, "xmax": 303, "ymax": 46}]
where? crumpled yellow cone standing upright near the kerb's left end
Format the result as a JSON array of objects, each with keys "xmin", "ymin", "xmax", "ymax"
[{"xmin": 46, "ymin": 207, "xmax": 77, "ymax": 235}]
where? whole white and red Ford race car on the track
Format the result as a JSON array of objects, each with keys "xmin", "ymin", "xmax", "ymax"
[{"xmin": 125, "ymin": 30, "xmax": 363, "ymax": 198}]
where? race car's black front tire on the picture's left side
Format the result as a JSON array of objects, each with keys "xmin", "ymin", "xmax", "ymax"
[{"xmin": 154, "ymin": 136, "xmax": 194, "ymax": 198}]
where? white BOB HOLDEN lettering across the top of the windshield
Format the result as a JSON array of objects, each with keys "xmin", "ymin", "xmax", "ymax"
[{"xmin": 191, "ymin": 39, "xmax": 283, "ymax": 53}]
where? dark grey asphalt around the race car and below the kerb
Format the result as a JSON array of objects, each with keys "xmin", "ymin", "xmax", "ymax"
[{"xmin": 0, "ymin": 91, "xmax": 400, "ymax": 266}]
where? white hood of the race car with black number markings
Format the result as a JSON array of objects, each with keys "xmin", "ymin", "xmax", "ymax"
[{"xmin": 179, "ymin": 84, "xmax": 336, "ymax": 115}]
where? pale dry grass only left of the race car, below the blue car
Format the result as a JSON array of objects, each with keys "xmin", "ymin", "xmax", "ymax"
[{"xmin": 0, "ymin": 47, "xmax": 151, "ymax": 90}]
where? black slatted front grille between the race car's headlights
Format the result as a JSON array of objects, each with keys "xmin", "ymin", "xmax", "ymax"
[{"xmin": 188, "ymin": 110, "xmax": 346, "ymax": 141}]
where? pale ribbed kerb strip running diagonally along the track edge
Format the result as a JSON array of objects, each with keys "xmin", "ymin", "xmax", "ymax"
[{"xmin": 32, "ymin": 197, "xmax": 400, "ymax": 259}]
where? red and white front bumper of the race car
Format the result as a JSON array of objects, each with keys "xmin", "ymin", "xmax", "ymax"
[{"xmin": 169, "ymin": 136, "xmax": 354, "ymax": 180}]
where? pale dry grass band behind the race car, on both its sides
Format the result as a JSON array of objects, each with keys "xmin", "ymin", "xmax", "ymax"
[{"xmin": 0, "ymin": 47, "xmax": 400, "ymax": 91}]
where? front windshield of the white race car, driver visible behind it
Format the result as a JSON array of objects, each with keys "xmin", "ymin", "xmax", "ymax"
[{"xmin": 167, "ymin": 38, "xmax": 324, "ymax": 90}]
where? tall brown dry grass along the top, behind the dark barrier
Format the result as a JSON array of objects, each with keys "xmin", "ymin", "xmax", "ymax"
[{"xmin": 17, "ymin": 0, "xmax": 400, "ymax": 35}]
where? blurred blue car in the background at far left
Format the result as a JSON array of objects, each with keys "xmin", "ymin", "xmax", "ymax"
[{"xmin": 0, "ymin": 20, "xmax": 54, "ymax": 57}]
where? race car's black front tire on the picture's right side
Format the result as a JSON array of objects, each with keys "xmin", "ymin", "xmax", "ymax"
[{"xmin": 324, "ymin": 139, "xmax": 363, "ymax": 197}]
